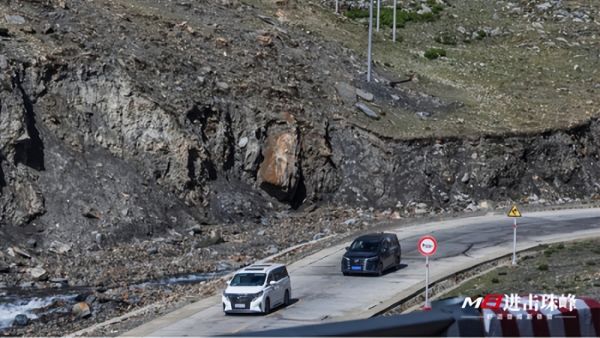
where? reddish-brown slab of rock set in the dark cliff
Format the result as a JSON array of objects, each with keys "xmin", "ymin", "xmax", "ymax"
[{"xmin": 258, "ymin": 129, "xmax": 300, "ymax": 200}]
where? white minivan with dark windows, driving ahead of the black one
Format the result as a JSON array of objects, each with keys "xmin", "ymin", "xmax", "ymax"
[{"xmin": 222, "ymin": 264, "xmax": 292, "ymax": 314}]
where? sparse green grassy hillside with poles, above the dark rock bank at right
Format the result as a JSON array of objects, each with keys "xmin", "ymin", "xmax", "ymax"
[{"xmin": 245, "ymin": 0, "xmax": 600, "ymax": 138}]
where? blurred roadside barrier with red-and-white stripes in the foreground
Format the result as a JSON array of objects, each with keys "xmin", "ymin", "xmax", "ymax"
[{"xmin": 234, "ymin": 298, "xmax": 600, "ymax": 337}]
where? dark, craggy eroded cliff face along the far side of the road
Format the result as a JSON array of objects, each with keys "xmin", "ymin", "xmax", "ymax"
[{"xmin": 0, "ymin": 1, "xmax": 600, "ymax": 249}]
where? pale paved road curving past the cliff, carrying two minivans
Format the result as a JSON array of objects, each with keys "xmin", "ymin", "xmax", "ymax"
[{"xmin": 126, "ymin": 209, "xmax": 600, "ymax": 336}]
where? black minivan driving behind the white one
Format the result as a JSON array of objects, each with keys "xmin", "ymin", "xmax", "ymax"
[{"xmin": 342, "ymin": 232, "xmax": 401, "ymax": 276}]
